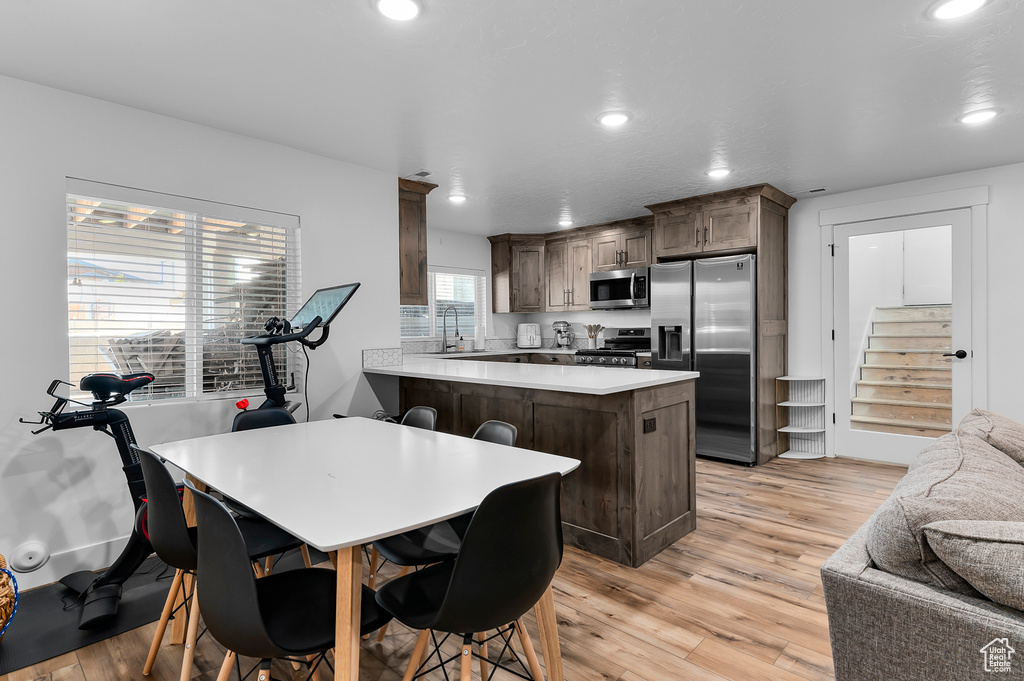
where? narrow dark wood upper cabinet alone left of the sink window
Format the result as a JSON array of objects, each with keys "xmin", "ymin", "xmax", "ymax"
[{"xmin": 398, "ymin": 179, "xmax": 437, "ymax": 305}]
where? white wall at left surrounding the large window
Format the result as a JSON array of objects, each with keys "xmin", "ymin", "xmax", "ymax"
[{"xmin": 0, "ymin": 73, "xmax": 398, "ymax": 588}]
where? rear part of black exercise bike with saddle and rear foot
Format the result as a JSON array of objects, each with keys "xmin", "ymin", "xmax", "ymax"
[{"xmin": 18, "ymin": 374, "xmax": 154, "ymax": 629}]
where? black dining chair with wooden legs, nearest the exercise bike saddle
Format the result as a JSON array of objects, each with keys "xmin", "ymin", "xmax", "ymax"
[{"xmin": 131, "ymin": 444, "xmax": 302, "ymax": 681}]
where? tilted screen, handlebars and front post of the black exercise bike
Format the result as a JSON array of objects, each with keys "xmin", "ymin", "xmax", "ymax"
[{"xmin": 232, "ymin": 282, "xmax": 359, "ymax": 413}]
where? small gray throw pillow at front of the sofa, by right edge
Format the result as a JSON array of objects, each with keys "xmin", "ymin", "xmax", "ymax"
[{"xmin": 924, "ymin": 520, "xmax": 1024, "ymax": 610}]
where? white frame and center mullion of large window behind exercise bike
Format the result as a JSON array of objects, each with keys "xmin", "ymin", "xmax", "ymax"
[{"xmin": 65, "ymin": 177, "xmax": 306, "ymax": 405}]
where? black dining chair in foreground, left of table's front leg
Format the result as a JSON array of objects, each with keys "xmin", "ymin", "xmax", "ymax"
[{"xmin": 185, "ymin": 481, "xmax": 391, "ymax": 681}]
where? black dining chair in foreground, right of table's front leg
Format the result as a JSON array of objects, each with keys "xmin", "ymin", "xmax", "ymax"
[{"xmin": 377, "ymin": 473, "xmax": 562, "ymax": 681}]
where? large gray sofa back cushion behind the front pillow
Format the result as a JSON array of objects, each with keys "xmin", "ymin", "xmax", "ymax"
[{"xmin": 867, "ymin": 432, "xmax": 1024, "ymax": 594}]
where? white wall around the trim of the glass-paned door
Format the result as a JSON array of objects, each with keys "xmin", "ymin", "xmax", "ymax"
[{"xmin": 788, "ymin": 164, "xmax": 1024, "ymax": 421}]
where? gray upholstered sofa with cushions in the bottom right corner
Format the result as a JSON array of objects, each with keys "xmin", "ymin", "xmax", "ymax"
[{"xmin": 821, "ymin": 410, "xmax": 1024, "ymax": 681}]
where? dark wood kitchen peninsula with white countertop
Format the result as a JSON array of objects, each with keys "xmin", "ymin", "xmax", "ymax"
[{"xmin": 364, "ymin": 355, "xmax": 698, "ymax": 567}]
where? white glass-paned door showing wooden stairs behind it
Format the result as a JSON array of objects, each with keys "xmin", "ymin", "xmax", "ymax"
[{"xmin": 833, "ymin": 209, "xmax": 972, "ymax": 463}]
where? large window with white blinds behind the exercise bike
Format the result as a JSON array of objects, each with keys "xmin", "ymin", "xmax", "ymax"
[{"xmin": 68, "ymin": 181, "xmax": 301, "ymax": 400}]
